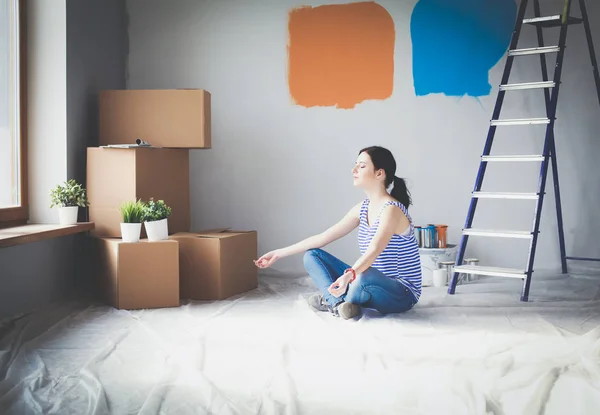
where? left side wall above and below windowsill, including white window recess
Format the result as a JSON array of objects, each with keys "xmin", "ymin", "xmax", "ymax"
[{"xmin": 0, "ymin": 0, "xmax": 127, "ymax": 316}]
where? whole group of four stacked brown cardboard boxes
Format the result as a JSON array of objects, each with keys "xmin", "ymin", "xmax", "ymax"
[{"xmin": 86, "ymin": 89, "xmax": 257, "ymax": 309}]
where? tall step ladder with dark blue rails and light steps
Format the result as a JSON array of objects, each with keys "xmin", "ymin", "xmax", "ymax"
[{"xmin": 448, "ymin": 0, "xmax": 600, "ymax": 301}]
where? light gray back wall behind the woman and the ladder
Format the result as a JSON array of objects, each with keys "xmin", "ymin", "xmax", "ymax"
[{"xmin": 127, "ymin": 0, "xmax": 600, "ymax": 271}]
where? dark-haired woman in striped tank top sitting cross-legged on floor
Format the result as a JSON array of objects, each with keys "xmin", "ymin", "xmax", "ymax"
[{"xmin": 255, "ymin": 146, "xmax": 422, "ymax": 319}]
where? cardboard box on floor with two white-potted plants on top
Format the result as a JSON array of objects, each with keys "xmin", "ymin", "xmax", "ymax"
[{"xmin": 95, "ymin": 238, "xmax": 179, "ymax": 310}]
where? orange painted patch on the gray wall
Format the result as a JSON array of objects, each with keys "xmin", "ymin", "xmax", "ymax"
[{"xmin": 288, "ymin": 2, "xmax": 396, "ymax": 109}]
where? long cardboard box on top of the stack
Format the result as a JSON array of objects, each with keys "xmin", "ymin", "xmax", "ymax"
[{"xmin": 99, "ymin": 89, "xmax": 211, "ymax": 148}]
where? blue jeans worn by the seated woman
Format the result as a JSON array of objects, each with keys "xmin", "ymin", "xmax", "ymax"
[{"xmin": 304, "ymin": 249, "xmax": 416, "ymax": 314}]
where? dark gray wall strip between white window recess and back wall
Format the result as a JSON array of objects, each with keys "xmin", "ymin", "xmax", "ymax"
[{"xmin": 67, "ymin": 0, "xmax": 128, "ymax": 187}]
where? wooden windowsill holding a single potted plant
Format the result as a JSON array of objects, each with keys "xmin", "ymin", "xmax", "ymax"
[{"xmin": 0, "ymin": 222, "xmax": 94, "ymax": 248}]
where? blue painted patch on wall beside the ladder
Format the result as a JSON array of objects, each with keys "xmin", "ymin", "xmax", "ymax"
[{"xmin": 410, "ymin": 0, "xmax": 517, "ymax": 97}]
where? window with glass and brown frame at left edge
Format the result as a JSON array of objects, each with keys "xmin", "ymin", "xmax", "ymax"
[{"xmin": 0, "ymin": 0, "xmax": 29, "ymax": 227}]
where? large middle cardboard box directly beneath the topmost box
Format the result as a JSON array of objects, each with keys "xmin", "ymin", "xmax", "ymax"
[{"xmin": 86, "ymin": 147, "xmax": 191, "ymax": 238}]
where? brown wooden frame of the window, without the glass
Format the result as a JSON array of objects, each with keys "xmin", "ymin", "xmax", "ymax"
[{"xmin": 0, "ymin": 0, "xmax": 29, "ymax": 228}]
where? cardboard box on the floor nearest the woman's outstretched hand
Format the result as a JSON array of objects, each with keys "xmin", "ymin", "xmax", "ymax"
[{"xmin": 170, "ymin": 230, "xmax": 258, "ymax": 300}]
